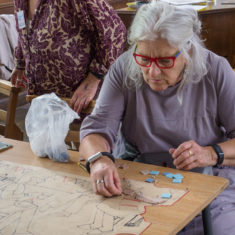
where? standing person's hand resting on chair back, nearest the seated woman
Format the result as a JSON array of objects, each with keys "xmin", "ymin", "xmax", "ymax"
[{"xmin": 70, "ymin": 73, "xmax": 100, "ymax": 114}]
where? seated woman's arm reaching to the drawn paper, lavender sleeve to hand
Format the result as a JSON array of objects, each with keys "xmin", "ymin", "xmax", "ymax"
[{"xmin": 80, "ymin": 51, "xmax": 127, "ymax": 197}]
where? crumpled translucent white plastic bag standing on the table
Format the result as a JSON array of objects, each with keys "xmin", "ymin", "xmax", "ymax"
[{"xmin": 25, "ymin": 93, "xmax": 79, "ymax": 162}]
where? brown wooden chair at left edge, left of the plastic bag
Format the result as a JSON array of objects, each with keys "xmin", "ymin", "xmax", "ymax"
[{"xmin": 0, "ymin": 79, "xmax": 23, "ymax": 140}]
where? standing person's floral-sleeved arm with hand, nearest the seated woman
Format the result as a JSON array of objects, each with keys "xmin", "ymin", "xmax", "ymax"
[{"xmin": 70, "ymin": 0, "xmax": 126, "ymax": 113}]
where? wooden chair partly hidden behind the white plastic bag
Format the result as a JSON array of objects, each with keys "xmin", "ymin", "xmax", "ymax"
[{"xmin": 26, "ymin": 95, "xmax": 96, "ymax": 149}]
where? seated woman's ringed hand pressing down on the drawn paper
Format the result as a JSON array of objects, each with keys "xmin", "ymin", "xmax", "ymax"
[{"xmin": 90, "ymin": 156, "xmax": 122, "ymax": 197}]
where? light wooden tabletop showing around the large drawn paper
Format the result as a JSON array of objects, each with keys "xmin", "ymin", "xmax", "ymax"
[{"xmin": 0, "ymin": 137, "xmax": 229, "ymax": 235}]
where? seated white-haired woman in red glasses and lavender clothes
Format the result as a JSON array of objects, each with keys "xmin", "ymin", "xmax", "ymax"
[{"xmin": 80, "ymin": 0, "xmax": 235, "ymax": 235}]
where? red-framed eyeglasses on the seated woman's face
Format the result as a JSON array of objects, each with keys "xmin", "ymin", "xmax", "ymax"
[{"xmin": 133, "ymin": 46, "xmax": 181, "ymax": 69}]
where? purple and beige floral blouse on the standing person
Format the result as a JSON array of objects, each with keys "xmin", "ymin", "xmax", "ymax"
[{"xmin": 14, "ymin": 0, "xmax": 126, "ymax": 97}]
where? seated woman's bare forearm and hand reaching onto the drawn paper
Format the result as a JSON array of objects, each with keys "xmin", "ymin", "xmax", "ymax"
[{"xmin": 79, "ymin": 134, "xmax": 122, "ymax": 197}]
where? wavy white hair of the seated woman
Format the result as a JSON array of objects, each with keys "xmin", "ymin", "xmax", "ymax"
[{"xmin": 124, "ymin": 0, "xmax": 207, "ymax": 103}]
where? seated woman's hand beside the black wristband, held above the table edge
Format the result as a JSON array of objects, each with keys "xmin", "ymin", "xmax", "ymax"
[{"xmin": 169, "ymin": 140, "xmax": 217, "ymax": 170}]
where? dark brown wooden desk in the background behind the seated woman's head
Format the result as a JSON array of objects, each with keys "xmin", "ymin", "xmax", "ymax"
[{"xmin": 115, "ymin": 0, "xmax": 235, "ymax": 68}]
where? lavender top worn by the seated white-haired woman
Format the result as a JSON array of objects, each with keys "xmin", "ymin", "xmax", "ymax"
[{"xmin": 80, "ymin": 50, "xmax": 235, "ymax": 160}]
